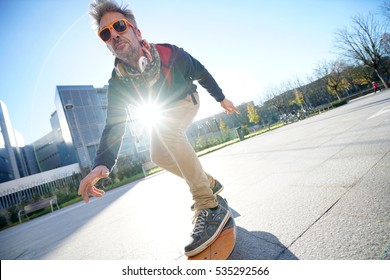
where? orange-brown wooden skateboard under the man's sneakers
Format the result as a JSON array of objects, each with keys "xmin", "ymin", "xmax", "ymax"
[{"xmin": 187, "ymin": 196, "xmax": 236, "ymax": 260}]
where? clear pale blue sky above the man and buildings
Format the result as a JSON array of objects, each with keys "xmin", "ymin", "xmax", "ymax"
[{"xmin": 0, "ymin": 0, "xmax": 383, "ymax": 144}]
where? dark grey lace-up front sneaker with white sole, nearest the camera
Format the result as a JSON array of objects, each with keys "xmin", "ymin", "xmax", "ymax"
[{"xmin": 184, "ymin": 205, "xmax": 230, "ymax": 257}]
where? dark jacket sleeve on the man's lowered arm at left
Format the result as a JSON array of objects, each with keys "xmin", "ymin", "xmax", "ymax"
[{"xmin": 94, "ymin": 75, "xmax": 127, "ymax": 171}]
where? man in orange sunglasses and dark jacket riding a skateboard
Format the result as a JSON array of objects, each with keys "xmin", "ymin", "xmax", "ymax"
[{"xmin": 79, "ymin": 0, "xmax": 239, "ymax": 256}]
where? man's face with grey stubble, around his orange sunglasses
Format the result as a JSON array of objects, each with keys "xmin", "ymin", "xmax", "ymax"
[{"xmin": 99, "ymin": 12, "xmax": 142, "ymax": 65}]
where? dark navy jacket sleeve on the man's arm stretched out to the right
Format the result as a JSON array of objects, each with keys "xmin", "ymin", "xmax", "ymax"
[{"xmin": 179, "ymin": 48, "xmax": 225, "ymax": 102}]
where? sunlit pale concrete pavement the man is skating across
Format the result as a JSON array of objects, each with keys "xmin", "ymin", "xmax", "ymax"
[{"xmin": 0, "ymin": 90, "xmax": 390, "ymax": 260}]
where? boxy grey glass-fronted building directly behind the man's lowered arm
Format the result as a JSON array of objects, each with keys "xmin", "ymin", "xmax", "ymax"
[{"xmin": 55, "ymin": 85, "xmax": 149, "ymax": 169}]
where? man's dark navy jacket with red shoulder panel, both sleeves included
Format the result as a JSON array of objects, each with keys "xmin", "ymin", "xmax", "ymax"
[{"xmin": 94, "ymin": 44, "xmax": 225, "ymax": 170}]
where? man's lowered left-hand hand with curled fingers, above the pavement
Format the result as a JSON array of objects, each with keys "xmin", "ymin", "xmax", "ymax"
[{"xmin": 78, "ymin": 165, "xmax": 110, "ymax": 203}]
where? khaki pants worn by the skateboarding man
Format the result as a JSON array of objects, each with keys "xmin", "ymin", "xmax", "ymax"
[{"xmin": 150, "ymin": 93, "xmax": 217, "ymax": 210}]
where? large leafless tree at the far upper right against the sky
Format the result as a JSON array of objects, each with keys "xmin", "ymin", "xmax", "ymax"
[{"xmin": 336, "ymin": 14, "xmax": 390, "ymax": 88}]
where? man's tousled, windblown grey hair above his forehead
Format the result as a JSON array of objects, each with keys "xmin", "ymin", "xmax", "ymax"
[{"xmin": 89, "ymin": 0, "xmax": 138, "ymax": 29}]
